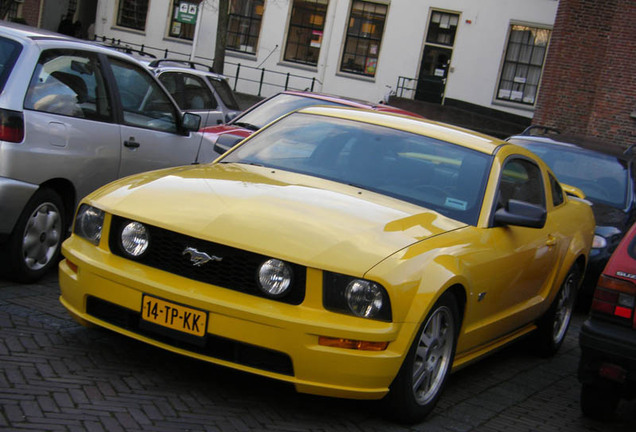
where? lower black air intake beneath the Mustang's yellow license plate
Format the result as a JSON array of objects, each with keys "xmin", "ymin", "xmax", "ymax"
[{"xmin": 86, "ymin": 296, "xmax": 294, "ymax": 376}]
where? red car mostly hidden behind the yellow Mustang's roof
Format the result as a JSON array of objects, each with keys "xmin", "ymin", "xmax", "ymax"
[{"xmin": 203, "ymin": 90, "xmax": 421, "ymax": 153}]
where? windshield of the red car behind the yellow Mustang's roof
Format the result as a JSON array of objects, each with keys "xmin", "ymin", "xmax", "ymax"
[{"xmin": 232, "ymin": 93, "xmax": 344, "ymax": 130}]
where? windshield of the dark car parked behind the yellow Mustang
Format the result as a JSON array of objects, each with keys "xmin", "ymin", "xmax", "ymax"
[{"xmin": 510, "ymin": 139, "xmax": 629, "ymax": 209}]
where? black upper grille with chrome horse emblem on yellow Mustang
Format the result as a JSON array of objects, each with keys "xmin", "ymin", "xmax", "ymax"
[{"xmin": 109, "ymin": 216, "xmax": 306, "ymax": 305}]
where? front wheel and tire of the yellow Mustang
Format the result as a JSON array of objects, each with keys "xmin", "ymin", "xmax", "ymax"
[{"xmin": 385, "ymin": 292, "xmax": 460, "ymax": 424}]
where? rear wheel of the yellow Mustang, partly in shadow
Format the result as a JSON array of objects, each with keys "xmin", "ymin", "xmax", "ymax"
[{"xmin": 536, "ymin": 264, "xmax": 581, "ymax": 357}]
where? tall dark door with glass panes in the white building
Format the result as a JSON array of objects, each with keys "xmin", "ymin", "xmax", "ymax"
[{"xmin": 415, "ymin": 11, "xmax": 459, "ymax": 104}]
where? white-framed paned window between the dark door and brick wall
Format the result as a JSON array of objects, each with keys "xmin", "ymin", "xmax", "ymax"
[{"xmin": 496, "ymin": 24, "xmax": 551, "ymax": 105}]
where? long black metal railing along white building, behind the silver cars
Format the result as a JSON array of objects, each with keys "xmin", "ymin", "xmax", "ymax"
[{"xmin": 95, "ymin": 35, "xmax": 322, "ymax": 97}]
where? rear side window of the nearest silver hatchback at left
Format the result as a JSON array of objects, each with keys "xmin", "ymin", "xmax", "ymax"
[{"xmin": 24, "ymin": 50, "xmax": 112, "ymax": 121}]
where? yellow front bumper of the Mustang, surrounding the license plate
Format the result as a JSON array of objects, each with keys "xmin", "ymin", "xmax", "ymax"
[{"xmin": 59, "ymin": 236, "xmax": 416, "ymax": 399}]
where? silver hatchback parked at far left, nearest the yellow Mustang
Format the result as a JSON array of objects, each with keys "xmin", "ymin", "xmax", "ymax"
[{"xmin": 0, "ymin": 21, "xmax": 210, "ymax": 281}]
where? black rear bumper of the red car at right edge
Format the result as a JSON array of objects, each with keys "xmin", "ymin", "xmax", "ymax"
[{"xmin": 578, "ymin": 318, "xmax": 636, "ymax": 397}]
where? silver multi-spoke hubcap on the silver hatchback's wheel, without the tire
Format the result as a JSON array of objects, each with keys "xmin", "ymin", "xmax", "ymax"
[{"xmin": 22, "ymin": 202, "xmax": 62, "ymax": 270}]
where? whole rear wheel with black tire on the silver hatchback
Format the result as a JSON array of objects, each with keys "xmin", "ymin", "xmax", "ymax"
[{"xmin": 5, "ymin": 188, "xmax": 67, "ymax": 283}]
